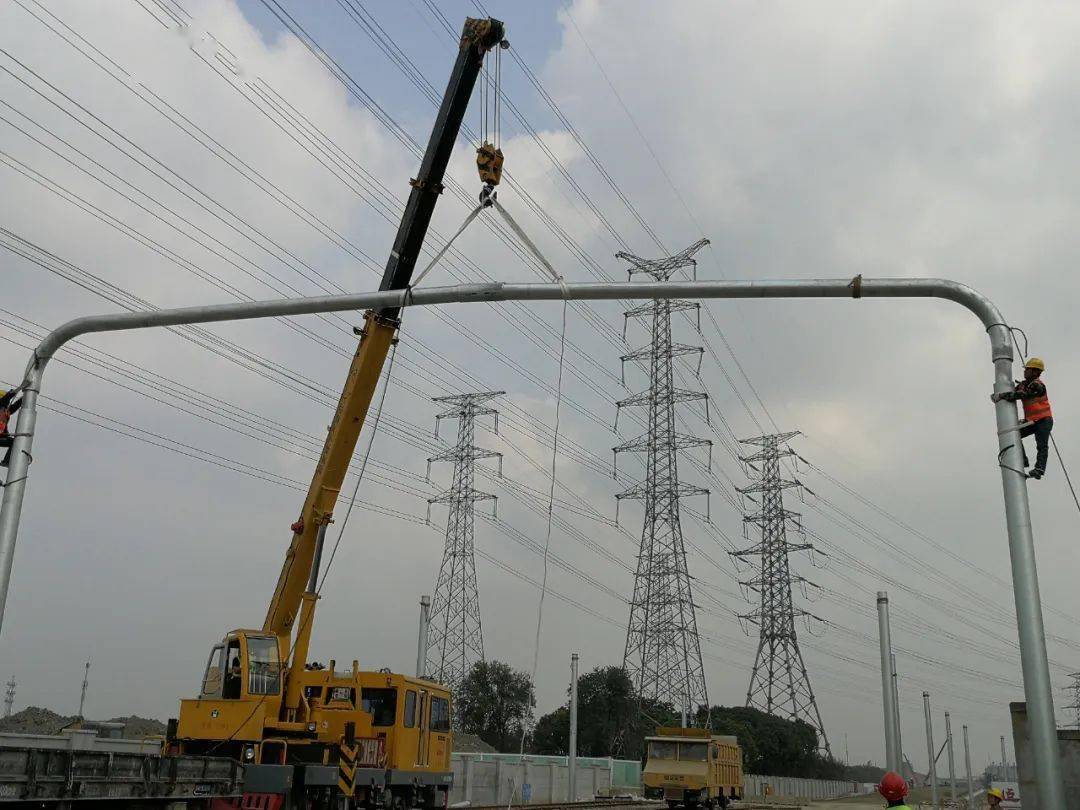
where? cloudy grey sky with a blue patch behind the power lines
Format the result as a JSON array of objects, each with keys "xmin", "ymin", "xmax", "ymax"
[{"xmin": 0, "ymin": 0, "xmax": 1080, "ymax": 768}]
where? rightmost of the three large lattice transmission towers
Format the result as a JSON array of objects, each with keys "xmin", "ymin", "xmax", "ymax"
[{"xmin": 733, "ymin": 431, "xmax": 832, "ymax": 755}]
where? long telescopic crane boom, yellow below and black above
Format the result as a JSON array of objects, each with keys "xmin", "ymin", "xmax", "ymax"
[{"xmin": 262, "ymin": 18, "xmax": 503, "ymax": 639}]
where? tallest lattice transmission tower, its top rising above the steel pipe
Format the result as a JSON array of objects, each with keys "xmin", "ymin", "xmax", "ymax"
[{"xmin": 613, "ymin": 239, "xmax": 712, "ymax": 720}]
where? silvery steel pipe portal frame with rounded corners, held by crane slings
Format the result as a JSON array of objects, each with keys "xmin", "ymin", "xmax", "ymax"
[{"xmin": 0, "ymin": 276, "xmax": 1066, "ymax": 810}]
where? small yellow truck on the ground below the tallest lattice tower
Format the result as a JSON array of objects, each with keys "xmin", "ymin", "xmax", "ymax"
[{"xmin": 642, "ymin": 728, "xmax": 742, "ymax": 810}]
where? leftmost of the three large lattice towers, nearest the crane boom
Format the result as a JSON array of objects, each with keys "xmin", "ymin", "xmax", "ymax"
[{"xmin": 427, "ymin": 391, "xmax": 505, "ymax": 692}]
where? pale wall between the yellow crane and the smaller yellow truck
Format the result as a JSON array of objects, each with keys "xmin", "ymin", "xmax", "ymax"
[{"xmin": 450, "ymin": 754, "xmax": 611, "ymax": 805}]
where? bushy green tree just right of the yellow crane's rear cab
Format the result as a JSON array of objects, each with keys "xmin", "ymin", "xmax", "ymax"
[{"xmin": 456, "ymin": 661, "xmax": 536, "ymax": 752}]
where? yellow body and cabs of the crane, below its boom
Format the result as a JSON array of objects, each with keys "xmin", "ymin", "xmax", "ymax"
[{"xmin": 168, "ymin": 630, "xmax": 454, "ymax": 809}]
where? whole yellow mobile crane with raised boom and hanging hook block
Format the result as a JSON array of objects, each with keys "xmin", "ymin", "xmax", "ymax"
[{"xmin": 166, "ymin": 18, "xmax": 504, "ymax": 810}]
